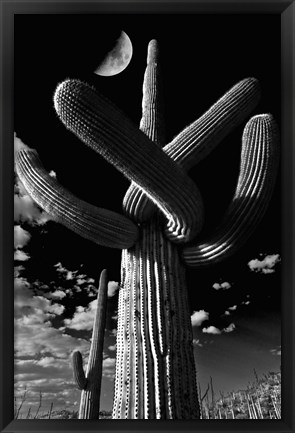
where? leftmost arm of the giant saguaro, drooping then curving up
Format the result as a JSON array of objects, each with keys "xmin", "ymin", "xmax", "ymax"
[{"xmin": 15, "ymin": 149, "xmax": 138, "ymax": 249}]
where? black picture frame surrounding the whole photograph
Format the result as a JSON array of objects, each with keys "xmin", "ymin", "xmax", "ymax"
[{"xmin": 0, "ymin": 0, "xmax": 295, "ymax": 433}]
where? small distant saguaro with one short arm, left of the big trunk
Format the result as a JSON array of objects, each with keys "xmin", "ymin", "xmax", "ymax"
[{"xmin": 72, "ymin": 269, "xmax": 108, "ymax": 419}]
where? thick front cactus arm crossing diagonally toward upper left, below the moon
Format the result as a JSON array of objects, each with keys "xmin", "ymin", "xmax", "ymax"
[{"xmin": 54, "ymin": 80, "xmax": 203, "ymax": 242}]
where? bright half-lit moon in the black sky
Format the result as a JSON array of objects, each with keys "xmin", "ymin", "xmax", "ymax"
[{"xmin": 94, "ymin": 31, "xmax": 133, "ymax": 77}]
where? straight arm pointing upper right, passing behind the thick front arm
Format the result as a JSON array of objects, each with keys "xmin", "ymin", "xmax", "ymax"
[{"xmin": 123, "ymin": 78, "xmax": 260, "ymax": 222}]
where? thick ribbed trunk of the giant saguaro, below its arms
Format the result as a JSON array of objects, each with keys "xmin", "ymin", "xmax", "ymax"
[{"xmin": 113, "ymin": 217, "xmax": 199, "ymax": 419}]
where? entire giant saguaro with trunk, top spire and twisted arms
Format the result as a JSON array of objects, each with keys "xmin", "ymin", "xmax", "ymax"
[{"xmin": 16, "ymin": 40, "xmax": 278, "ymax": 419}]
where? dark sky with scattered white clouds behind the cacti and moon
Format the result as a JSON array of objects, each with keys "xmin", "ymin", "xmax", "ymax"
[{"xmin": 14, "ymin": 15, "xmax": 281, "ymax": 413}]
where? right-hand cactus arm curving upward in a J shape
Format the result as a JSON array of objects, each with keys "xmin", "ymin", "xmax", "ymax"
[{"xmin": 183, "ymin": 114, "xmax": 279, "ymax": 267}]
